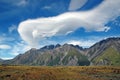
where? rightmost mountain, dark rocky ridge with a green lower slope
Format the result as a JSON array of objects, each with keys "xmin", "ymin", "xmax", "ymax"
[{"xmin": 86, "ymin": 38, "xmax": 120, "ymax": 65}]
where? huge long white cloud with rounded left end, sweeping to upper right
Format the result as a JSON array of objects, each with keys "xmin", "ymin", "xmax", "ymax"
[{"xmin": 18, "ymin": 0, "xmax": 120, "ymax": 47}]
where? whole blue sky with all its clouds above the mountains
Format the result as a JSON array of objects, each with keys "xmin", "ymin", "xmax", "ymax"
[{"xmin": 0, "ymin": 0, "xmax": 120, "ymax": 59}]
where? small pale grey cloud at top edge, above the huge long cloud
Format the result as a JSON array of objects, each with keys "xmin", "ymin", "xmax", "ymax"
[{"xmin": 69, "ymin": 0, "xmax": 88, "ymax": 11}]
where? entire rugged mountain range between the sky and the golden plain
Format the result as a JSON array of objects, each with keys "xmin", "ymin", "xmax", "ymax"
[{"xmin": 0, "ymin": 37, "xmax": 120, "ymax": 66}]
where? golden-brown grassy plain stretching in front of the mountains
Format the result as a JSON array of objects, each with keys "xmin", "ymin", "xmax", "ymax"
[{"xmin": 0, "ymin": 66, "xmax": 120, "ymax": 80}]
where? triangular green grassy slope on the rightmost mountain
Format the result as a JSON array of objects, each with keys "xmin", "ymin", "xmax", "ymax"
[{"xmin": 93, "ymin": 47, "xmax": 120, "ymax": 66}]
